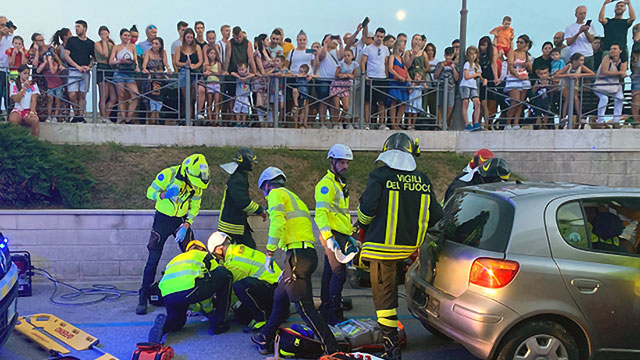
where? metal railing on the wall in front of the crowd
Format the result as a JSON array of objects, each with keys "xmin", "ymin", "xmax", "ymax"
[{"xmin": 0, "ymin": 66, "xmax": 640, "ymax": 130}]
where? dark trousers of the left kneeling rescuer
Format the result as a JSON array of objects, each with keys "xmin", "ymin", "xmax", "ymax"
[{"xmin": 162, "ymin": 266, "xmax": 233, "ymax": 334}]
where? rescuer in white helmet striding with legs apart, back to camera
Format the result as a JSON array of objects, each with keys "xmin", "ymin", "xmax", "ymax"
[{"xmin": 251, "ymin": 167, "xmax": 338, "ymax": 354}]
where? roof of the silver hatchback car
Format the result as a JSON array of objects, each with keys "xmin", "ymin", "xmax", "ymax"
[{"xmin": 464, "ymin": 181, "xmax": 640, "ymax": 200}]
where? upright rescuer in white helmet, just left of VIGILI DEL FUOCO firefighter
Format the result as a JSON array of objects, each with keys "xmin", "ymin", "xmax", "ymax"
[{"xmin": 314, "ymin": 144, "xmax": 358, "ymax": 325}]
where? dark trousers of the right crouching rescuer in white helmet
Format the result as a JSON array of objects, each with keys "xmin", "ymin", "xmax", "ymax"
[{"xmin": 233, "ymin": 277, "xmax": 278, "ymax": 322}]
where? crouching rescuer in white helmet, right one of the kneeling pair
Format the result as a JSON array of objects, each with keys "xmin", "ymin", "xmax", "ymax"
[{"xmin": 207, "ymin": 231, "xmax": 282, "ymax": 332}]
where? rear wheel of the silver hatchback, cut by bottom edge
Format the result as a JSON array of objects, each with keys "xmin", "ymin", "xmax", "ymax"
[{"xmin": 495, "ymin": 320, "xmax": 580, "ymax": 360}]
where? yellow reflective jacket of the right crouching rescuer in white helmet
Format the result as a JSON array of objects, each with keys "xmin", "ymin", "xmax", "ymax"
[{"xmin": 224, "ymin": 244, "xmax": 282, "ymax": 284}]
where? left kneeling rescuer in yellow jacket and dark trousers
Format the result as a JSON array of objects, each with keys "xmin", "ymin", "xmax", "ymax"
[{"xmin": 149, "ymin": 240, "xmax": 233, "ymax": 343}]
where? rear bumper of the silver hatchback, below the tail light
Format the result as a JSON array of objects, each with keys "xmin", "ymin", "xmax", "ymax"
[{"xmin": 405, "ymin": 264, "xmax": 519, "ymax": 359}]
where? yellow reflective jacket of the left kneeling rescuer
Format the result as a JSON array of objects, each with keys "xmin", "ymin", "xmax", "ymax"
[{"xmin": 158, "ymin": 250, "xmax": 218, "ymax": 296}]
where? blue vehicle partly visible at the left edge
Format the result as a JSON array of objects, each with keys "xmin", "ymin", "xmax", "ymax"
[{"xmin": 0, "ymin": 233, "xmax": 18, "ymax": 348}]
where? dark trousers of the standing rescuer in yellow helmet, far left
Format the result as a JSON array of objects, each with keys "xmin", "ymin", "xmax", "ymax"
[{"xmin": 141, "ymin": 211, "xmax": 193, "ymax": 289}]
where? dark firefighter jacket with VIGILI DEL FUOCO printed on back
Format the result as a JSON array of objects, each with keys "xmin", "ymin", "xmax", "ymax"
[{"xmin": 358, "ymin": 165, "xmax": 442, "ymax": 260}]
